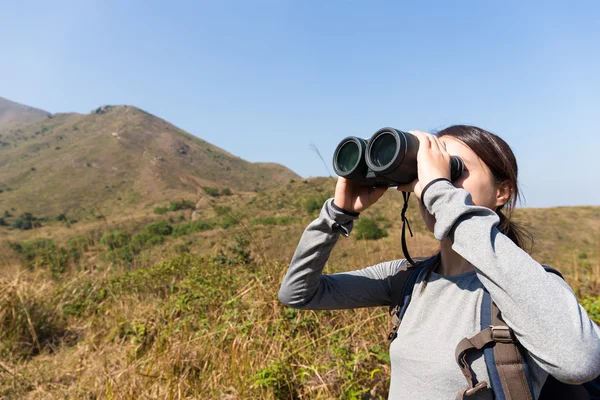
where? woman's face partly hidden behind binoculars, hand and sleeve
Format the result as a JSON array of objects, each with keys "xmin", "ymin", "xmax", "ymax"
[{"xmin": 419, "ymin": 136, "xmax": 510, "ymax": 232}]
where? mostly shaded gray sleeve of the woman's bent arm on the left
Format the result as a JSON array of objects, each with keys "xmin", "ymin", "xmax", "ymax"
[{"xmin": 278, "ymin": 198, "xmax": 404, "ymax": 309}]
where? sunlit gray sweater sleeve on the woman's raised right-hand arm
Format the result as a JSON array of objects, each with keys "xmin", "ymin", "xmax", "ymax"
[{"xmin": 423, "ymin": 180, "xmax": 600, "ymax": 383}]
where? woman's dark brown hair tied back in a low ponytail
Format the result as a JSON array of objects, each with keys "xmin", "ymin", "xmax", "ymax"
[{"xmin": 425, "ymin": 125, "xmax": 533, "ymax": 281}]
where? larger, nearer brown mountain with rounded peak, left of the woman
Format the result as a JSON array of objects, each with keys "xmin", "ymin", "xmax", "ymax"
[{"xmin": 0, "ymin": 100, "xmax": 301, "ymax": 218}]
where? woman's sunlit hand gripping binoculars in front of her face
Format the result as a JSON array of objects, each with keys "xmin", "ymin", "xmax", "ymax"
[{"xmin": 396, "ymin": 131, "xmax": 451, "ymax": 204}]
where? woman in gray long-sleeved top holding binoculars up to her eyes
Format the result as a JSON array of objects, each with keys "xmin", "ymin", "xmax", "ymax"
[{"xmin": 279, "ymin": 125, "xmax": 600, "ymax": 399}]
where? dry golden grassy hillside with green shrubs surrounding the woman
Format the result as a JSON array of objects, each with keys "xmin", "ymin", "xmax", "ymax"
[{"xmin": 0, "ymin": 178, "xmax": 600, "ymax": 399}]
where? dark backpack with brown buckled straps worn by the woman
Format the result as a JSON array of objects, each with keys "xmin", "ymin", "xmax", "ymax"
[{"xmin": 388, "ymin": 254, "xmax": 600, "ymax": 400}]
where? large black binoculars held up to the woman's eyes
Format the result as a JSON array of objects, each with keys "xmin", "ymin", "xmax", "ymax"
[{"xmin": 333, "ymin": 128, "xmax": 464, "ymax": 186}]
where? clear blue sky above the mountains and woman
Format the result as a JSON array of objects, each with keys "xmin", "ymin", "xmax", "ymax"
[{"xmin": 0, "ymin": 0, "xmax": 600, "ymax": 207}]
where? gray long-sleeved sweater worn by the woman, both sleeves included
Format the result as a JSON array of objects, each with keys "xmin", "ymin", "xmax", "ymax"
[{"xmin": 279, "ymin": 181, "xmax": 600, "ymax": 400}]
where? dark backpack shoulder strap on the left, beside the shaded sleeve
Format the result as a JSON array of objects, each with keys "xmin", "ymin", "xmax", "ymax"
[{"xmin": 388, "ymin": 256, "xmax": 437, "ymax": 342}]
